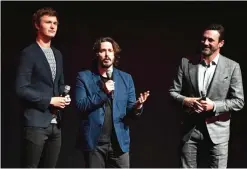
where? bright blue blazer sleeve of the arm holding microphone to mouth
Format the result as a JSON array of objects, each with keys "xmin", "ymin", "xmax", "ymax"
[{"xmin": 75, "ymin": 74, "xmax": 109, "ymax": 112}]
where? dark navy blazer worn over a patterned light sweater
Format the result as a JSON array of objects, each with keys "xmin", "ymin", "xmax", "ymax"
[{"xmin": 16, "ymin": 43, "xmax": 64, "ymax": 127}]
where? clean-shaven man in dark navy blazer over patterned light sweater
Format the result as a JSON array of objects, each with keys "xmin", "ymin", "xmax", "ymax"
[{"xmin": 16, "ymin": 8, "xmax": 70, "ymax": 168}]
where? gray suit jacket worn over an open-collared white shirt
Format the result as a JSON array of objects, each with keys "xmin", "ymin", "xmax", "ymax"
[{"xmin": 169, "ymin": 55, "xmax": 244, "ymax": 144}]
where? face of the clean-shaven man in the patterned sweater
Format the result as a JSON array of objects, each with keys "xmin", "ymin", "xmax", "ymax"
[{"xmin": 35, "ymin": 15, "xmax": 58, "ymax": 38}]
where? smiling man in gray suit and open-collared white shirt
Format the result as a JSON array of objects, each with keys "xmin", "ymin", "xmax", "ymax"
[{"xmin": 169, "ymin": 24, "xmax": 244, "ymax": 168}]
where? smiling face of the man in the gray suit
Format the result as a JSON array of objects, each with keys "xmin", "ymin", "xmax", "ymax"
[{"xmin": 201, "ymin": 30, "xmax": 224, "ymax": 57}]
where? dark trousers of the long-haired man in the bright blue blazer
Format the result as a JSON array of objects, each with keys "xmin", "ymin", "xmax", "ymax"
[{"xmin": 84, "ymin": 143, "xmax": 130, "ymax": 168}]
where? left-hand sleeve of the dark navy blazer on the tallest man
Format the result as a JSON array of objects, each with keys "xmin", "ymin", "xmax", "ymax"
[{"xmin": 16, "ymin": 52, "xmax": 51, "ymax": 111}]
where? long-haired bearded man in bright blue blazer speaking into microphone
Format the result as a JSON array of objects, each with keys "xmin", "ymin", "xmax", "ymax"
[{"xmin": 75, "ymin": 37, "xmax": 149, "ymax": 168}]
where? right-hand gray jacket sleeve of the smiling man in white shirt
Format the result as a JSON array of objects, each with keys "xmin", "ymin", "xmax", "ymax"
[{"xmin": 215, "ymin": 63, "xmax": 244, "ymax": 116}]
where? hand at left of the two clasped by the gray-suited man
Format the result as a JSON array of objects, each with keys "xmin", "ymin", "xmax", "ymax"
[{"xmin": 183, "ymin": 97, "xmax": 204, "ymax": 113}]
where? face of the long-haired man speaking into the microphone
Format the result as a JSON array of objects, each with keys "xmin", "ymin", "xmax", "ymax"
[{"xmin": 98, "ymin": 42, "xmax": 115, "ymax": 68}]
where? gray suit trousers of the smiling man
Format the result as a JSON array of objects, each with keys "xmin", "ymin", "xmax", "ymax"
[{"xmin": 180, "ymin": 123, "xmax": 228, "ymax": 168}]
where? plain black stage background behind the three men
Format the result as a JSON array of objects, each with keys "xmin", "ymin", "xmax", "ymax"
[{"xmin": 1, "ymin": 1, "xmax": 247, "ymax": 168}]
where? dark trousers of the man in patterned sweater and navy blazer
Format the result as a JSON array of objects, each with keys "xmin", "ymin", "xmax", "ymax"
[{"xmin": 23, "ymin": 124, "xmax": 61, "ymax": 168}]
